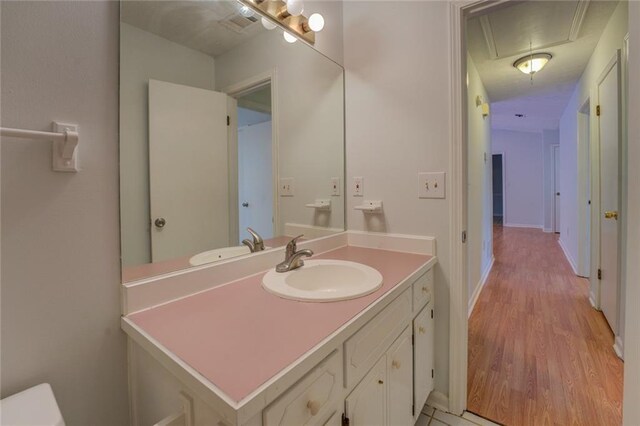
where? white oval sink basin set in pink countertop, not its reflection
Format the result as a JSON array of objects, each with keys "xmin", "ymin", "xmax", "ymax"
[{"xmin": 262, "ymin": 260, "xmax": 382, "ymax": 302}]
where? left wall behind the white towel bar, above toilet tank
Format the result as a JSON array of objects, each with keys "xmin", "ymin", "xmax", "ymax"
[{"xmin": 0, "ymin": 1, "xmax": 128, "ymax": 426}]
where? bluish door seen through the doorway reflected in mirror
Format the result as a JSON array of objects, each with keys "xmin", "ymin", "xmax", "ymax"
[{"xmin": 238, "ymin": 121, "xmax": 273, "ymax": 241}]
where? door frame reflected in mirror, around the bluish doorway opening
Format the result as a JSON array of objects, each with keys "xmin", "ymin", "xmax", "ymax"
[{"xmin": 222, "ymin": 68, "xmax": 281, "ymax": 243}]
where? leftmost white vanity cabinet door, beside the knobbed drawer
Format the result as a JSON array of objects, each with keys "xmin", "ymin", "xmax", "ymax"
[{"xmin": 345, "ymin": 356, "xmax": 387, "ymax": 426}]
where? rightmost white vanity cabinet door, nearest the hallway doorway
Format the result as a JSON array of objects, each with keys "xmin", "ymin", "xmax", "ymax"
[{"xmin": 413, "ymin": 303, "xmax": 434, "ymax": 420}]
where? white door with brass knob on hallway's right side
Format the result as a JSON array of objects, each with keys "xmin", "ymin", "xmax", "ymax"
[{"xmin": 596, "ymin": 55, "xmax": 620, "ymax": 334}]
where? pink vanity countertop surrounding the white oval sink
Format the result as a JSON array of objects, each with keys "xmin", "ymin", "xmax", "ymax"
[{"xmin": 128, "ymin": 247, "xmax": 431, "ymax": 402}]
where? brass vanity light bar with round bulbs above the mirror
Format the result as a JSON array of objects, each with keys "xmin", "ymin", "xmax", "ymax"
[{"xmin": 238, "ymin": 0, "xmax": 324, "ymax": 45}]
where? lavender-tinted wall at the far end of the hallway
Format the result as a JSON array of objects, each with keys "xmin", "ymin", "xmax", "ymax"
[{"xmin": 491, "ymin": 129, "xmax": 544, "ymax": 228}]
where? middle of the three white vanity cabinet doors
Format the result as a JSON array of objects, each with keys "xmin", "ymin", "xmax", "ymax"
[{"xmin": 387, "ymin": 327, "xmax": 413, "ymax": 426}]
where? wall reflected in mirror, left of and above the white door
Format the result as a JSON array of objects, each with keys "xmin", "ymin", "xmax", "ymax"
[{"xmin": 120, "ymin": 23, "xmax": 215, "ymax": 266}]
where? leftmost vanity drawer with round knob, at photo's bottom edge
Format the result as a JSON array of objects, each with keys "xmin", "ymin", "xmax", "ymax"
[{"xmin": 262, "ymin": 350, "xmax": 342, "ymax": 426}]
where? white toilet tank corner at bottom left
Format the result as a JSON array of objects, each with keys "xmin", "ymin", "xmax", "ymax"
[{"xmin": 0, "ymin": 383, "xmax": 64, "ymax": 426}]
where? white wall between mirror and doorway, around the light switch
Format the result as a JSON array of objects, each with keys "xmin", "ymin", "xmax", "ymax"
[{"xmin": 344, "ymin": 1, "xmax": 451, "ymax": 394}]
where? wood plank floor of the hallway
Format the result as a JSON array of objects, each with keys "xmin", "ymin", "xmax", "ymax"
[{"xmin": 467, "ymin": 226, "xmax": 623, "ymax": 426}]
